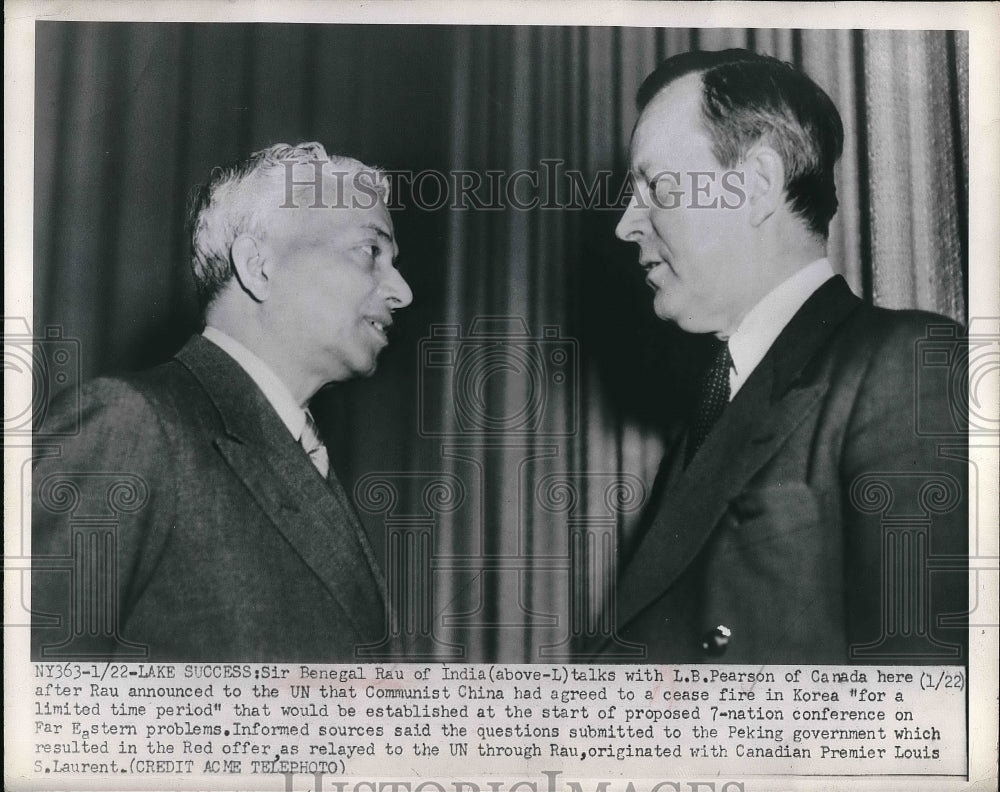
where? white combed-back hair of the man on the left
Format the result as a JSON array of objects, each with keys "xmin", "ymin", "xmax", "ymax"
[{"xmin": 188, "ymin": 142, "xmax": 389, "ymax": 312}]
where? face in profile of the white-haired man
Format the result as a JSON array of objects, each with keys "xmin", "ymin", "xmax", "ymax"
[{"xmin": 264, "ymin": 179, "xmax": 413, "ymax": 390}]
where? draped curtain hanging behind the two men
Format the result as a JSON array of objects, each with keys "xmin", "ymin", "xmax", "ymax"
[{"xmin": 33, "ymin": 22, "xmax": 968, "ymax": 662}]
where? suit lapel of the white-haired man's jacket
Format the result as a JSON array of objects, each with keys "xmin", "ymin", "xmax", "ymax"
[{"xmin": 177, "ymin": 336, "xmax": 385, "ymax": 633}]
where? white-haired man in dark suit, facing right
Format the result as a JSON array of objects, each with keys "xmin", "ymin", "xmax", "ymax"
[{"xmin": 32, "ymin": 143, "xmax": 412, "ymax": 662}]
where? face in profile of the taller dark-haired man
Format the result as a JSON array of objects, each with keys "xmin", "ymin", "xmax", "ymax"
[{"xmin": 615, "ymin": 74, "xmax": 746, "ymax": 333}]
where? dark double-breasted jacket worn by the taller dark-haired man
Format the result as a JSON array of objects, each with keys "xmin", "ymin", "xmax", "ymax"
[{"xmin": 603, "ymin": 277, "xmax": 968, "ymax": 664}]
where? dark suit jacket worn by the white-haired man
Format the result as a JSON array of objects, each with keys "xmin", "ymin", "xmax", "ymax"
[{"xmin": 32, "ymin": 336, "xmax": 385, "ymax": 662}]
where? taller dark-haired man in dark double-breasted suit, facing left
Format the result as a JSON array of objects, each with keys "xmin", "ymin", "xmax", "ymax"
[{"xmin": 599, "ymin": 50, "xmax": 968, "ymax": 664}]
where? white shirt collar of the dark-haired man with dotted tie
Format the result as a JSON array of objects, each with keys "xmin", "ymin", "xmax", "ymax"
[{"xmin": 729, "ymin": 258, "xmax": 834, "ymax": 401}]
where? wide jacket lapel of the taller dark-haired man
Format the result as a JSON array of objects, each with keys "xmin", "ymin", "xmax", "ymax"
[{"xmin": 618, "ymin": 276, "xmax": 860, "ymax": 625}]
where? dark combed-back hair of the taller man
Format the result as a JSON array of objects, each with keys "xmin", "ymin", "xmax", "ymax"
[{"xmin": 636, "ymin": 49, "xmax": 844, "ymax": 239}]
